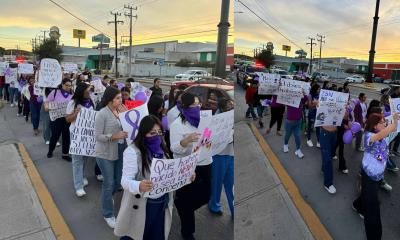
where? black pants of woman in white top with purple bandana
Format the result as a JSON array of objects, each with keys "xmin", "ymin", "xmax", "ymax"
[{"xmin": 174, "ymin": 164, "xmax": 211, "ymax": 236}]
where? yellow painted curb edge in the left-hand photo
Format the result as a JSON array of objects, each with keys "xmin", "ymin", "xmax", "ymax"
[{"xmin": 18, "ymin": 143, "xmax": 75, "ymax": 240}]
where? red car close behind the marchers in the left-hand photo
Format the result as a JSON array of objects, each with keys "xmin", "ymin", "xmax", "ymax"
[{"xmin": 185, "ymin": 84, "xmax": 235, "ymax": 114}]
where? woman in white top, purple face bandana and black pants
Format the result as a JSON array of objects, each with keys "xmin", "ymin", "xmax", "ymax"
[{"xmin": 170, "ymin": 92, "xmax": 212, "ymax": 239}]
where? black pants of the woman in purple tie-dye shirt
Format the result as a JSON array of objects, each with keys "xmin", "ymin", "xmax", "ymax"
[{"xmin": 353, "ymin": 171, "xmax": 382, "ymax": 240}]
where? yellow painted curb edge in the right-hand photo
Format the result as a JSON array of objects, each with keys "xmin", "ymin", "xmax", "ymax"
[{"xmin": 249, "ymin": 123, "xmax": 333, "ymax": 240}]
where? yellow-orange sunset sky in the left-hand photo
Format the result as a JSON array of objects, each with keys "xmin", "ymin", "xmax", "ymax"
[{"xmin": 0, "ymin": 0, "xmax": 233, "ymax": 50}]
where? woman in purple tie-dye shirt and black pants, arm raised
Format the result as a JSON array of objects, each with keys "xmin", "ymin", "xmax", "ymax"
[{"xmin": 353, "ymin": 113, "xmax": 399, "ymax": 240}]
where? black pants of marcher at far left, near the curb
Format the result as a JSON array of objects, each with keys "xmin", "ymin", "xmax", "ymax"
[{"xmin": 49, "ymin": 117, "xmax": 70, "ymax": 155}]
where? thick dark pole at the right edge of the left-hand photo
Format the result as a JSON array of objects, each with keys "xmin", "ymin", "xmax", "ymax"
[{"xmin": 215, "ymin": 0, "xmax": 230, "ymax": 78}]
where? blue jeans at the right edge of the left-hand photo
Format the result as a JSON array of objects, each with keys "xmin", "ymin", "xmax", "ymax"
[{"xmin": 208, "ymin": 155, "xmax": 234, "ymax": 217}]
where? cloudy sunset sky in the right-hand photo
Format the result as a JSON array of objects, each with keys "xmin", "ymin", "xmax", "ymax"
[{"xmin": 235, "ymin": 0, "xmax": 400, "ymax": 61}]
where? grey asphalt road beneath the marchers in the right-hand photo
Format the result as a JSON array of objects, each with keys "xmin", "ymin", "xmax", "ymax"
[{"xmin": 235, "ymin": 82, "xmax": 400, "ymax": 240}]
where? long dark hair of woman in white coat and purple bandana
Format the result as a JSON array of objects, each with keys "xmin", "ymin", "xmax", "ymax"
[{"xmin": 133, "ymin": 115, "xmax": 170, "ymax": 176}]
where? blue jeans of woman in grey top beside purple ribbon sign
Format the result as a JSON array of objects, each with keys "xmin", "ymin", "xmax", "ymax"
[{"xmin": 96, "ymin": 144, "xmax": 125, "ymax": 218}]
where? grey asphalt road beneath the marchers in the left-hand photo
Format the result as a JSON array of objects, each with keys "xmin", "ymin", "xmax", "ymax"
[{"xmin": 0, "ymin": 81, "xmax": 233, "ymax": 240}]
